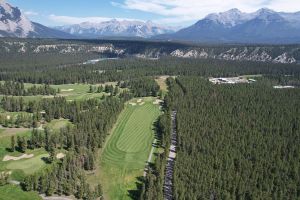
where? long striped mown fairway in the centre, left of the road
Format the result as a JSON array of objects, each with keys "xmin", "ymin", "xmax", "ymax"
[{"xmin": 100, "ymin": 98, "xmax": 161, "ymax": 200}]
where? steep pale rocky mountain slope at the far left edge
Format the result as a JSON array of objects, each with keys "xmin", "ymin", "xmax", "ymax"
[{"xmin": 0, "ymin": 0, "xmax": 74, "ymax": 38}]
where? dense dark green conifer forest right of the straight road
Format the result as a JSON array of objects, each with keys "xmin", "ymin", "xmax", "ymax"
[{"xmin": 166, "ymin": 77, "xmax": 300, "ymax": 199}]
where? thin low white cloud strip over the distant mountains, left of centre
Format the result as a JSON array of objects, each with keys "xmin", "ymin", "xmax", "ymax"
[{"xmin": 48, "ymin": 14, "xmax": 141, "ymax": 24}]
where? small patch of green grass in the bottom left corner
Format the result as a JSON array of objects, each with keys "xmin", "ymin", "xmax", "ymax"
[{"xmin": 0, "ymin": 185, "xmax": 42, "ymax": 200}]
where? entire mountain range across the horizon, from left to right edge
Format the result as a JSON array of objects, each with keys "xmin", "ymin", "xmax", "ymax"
[{"xmin": 0, "ymin": 0, "xmax": 300, "ymax": 43}]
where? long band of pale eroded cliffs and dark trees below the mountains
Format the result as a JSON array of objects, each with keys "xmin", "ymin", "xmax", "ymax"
[{"xmin": 0, "ymin": 39, "xmax": 300, "ymax": 63}]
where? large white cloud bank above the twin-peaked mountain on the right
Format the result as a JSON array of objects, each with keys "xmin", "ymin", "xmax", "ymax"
[{"xmin": 112, "ymin": 0, "xmax": 300, "ymax": 23}]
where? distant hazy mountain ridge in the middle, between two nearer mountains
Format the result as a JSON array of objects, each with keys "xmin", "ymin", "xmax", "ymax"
[{"xmin": 54, "ymin": 19, "xmax": 175, "ymax": 38}]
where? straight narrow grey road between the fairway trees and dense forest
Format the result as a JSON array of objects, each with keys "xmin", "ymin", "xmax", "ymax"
[{"xmin": 164, "ymin": 111, "xmax": 177, "ymax": 200}]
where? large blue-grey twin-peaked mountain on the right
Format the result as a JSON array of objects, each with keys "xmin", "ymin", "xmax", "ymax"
[{"xmin": 156, "ymin": 9, "xmax": 300, "ymax": 43}]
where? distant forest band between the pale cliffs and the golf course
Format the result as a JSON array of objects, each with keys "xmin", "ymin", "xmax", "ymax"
[{"xmin": 0, "ymin": 56, "xmax": 300, "ymax": 84}]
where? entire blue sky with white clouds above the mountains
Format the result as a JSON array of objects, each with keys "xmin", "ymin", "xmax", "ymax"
[{"xmin": 6, "ymin": 0, "xmax": 300, "ymax": 26}]
